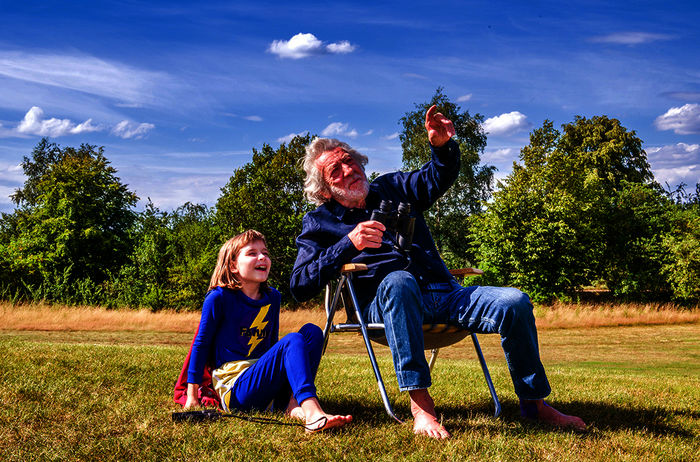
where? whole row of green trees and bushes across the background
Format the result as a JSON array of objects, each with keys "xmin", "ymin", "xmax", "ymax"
[{"xmin": 0, "ymin": 88, "xmax": 700, "ymax": 310}]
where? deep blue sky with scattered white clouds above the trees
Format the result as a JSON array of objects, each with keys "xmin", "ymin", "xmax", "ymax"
[{"xmin": 0, "ymin": 0, "xmax": 700, "ymax": 211}]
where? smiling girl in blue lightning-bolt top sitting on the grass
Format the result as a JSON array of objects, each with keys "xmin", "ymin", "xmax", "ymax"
[{"xmin": 185, "ymin": 230, "xmax": 352, "ymax": 431}]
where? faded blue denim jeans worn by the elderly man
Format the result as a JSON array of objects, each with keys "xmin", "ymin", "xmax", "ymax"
[{"xmin": 363, "ymin": 271, "xmax": 551, "ymax": 399}]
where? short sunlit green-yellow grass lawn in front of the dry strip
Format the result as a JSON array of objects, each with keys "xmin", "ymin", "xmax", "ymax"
[{"xmin": 0, "ymin": 324, "xmax": 700, "ymax": 461}]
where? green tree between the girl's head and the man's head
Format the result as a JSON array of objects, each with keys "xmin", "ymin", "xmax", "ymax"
[{"xmin": 215, "ymin": 134, "xmax": 311, "ymax": 299}]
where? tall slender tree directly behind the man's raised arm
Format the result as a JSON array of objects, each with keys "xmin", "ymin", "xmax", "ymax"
[{"xmin": 399, "ymin": 87, "xmax": 495, "ymax": 266}]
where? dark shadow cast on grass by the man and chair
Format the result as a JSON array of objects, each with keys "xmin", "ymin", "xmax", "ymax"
[{"xmin": 324, "ymin": 397, "xmax": 700, "ymax": 438}]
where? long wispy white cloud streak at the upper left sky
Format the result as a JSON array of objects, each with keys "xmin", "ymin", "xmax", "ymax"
[{"xmin": 0, "ymin": 51, "xmax": 169, "ymax": 106}]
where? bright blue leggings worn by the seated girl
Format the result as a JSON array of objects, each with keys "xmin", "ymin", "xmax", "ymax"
[{"xmin": 229, "ymin": 324, "xmax": 323, "ymax": 410}]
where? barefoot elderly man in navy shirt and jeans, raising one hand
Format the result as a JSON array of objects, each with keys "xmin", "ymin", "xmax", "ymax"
[{"xmin": 291, "ymin": 106, "xmax": 586, "ymax": 438}]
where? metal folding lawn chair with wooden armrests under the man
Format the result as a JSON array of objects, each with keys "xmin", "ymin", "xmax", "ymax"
[{"xmin": 323, "ymin": 263, "xmax": 501, "ymax": 423}]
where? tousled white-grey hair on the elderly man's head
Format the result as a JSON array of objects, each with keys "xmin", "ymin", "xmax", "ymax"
[{"xmin": 303, "ymin": 137, "xmax": 367, "ymax": 205}]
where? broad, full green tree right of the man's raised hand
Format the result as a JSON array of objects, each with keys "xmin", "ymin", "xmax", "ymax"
[{"xmin": 472, "ymin": 116, "xmax": 666, "ymax": 299}]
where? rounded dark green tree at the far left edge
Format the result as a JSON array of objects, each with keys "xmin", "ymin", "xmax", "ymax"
[{"xmin": 1, "ymin": 139, "xmax": 138, "ymax": 297}]
